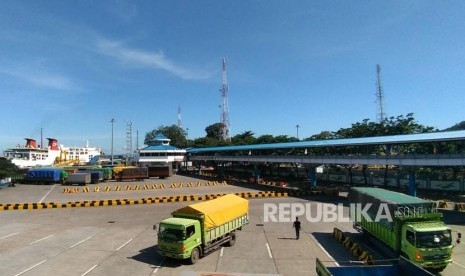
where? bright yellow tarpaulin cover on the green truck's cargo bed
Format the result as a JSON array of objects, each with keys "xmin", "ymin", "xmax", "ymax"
[{"xmin": 173, "ymin": 194, "xmax": 249, "ymax": 230}]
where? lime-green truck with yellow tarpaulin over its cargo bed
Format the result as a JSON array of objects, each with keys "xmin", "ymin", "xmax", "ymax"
[{"xmin": 154, "ymin": 194, "xmax": 249, "ymax": 264}]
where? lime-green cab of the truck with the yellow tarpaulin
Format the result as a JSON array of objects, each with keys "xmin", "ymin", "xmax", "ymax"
[{"xmin": 158, "ymin": 218, "xmax": 202, "ymax": 259}]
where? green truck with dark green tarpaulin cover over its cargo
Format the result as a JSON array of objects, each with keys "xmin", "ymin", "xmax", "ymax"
[{"xmin": 348, "ymin": 187, "xmax": 453, "ymax": 271}]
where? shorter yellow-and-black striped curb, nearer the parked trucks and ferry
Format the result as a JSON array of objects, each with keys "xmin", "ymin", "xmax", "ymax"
[{"xmin": 63, "ymin": 181, "xmax": 228, "ymax": 194}]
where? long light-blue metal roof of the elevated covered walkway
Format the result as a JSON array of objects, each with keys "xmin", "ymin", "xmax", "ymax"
[{"xmin": 187, "ymin": 130, "xmax": 465, "ymax": 153}]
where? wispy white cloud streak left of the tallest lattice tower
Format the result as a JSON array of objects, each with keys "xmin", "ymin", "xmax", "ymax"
[{"xmin": 97, "ymin": 39, "xmax": 211, "ymax": 80}]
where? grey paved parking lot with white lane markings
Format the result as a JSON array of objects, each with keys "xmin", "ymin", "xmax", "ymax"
[{"xmin": 0, "ymin": 176, "xmax": 465, "ymax": 276}]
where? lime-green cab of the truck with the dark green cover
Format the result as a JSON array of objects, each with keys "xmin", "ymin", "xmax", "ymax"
[{"xmin": 401, "ymin": 221, "xmax": 453, "ymax": 271}]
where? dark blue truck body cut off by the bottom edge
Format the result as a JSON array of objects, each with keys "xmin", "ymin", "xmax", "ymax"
[{"xmin": 316, "ymin": 256, "xmax": 434, "ymax": 276}]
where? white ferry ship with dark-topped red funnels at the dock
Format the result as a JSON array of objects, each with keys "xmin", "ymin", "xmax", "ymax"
[{"xmin": 3, "ymin": 138, "xmax": 102, "ymax": 168}]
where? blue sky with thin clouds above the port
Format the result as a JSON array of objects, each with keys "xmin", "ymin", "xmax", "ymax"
[{"xmin": 0, "ymin": 0, "xmax": 465, "ymax": 152}]
